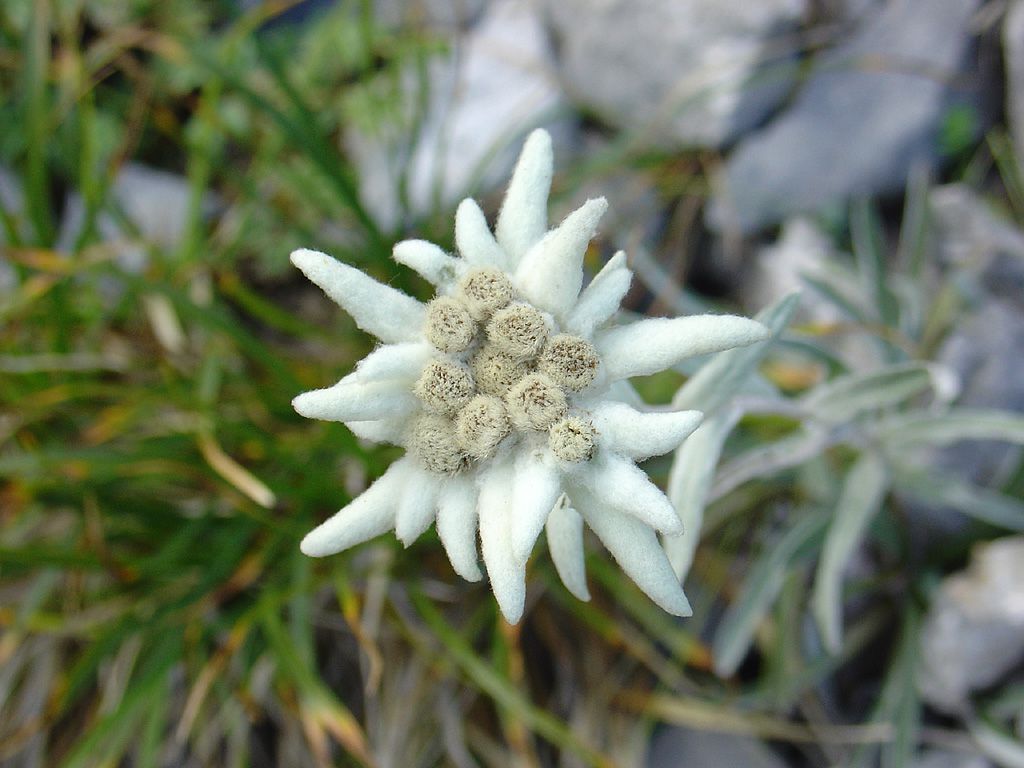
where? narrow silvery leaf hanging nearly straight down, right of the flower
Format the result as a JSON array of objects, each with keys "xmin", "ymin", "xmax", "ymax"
[{"xmin": 812, "ymin": 453, "xmax": 889, "ymax": 653}]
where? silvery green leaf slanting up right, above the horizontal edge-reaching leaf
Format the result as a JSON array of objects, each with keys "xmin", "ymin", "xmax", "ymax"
[{"xmin": 801, "ymin": 362, "xmax": 936, "ymax": 424}]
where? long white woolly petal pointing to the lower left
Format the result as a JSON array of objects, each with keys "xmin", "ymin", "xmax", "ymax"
[{"xmin": 299, "ymin": 459, "xmax": 415, "ymax": 557}]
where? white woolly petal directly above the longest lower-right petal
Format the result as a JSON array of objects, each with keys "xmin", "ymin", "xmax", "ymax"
[{"xmin": 572, "ymin": 451, "xmax": 683, "ymax": 535}]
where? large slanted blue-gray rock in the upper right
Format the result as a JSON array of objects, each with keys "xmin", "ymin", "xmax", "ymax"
[{"xmin": 709, "ymin": 0, "xmax": 982, "ymax": 231}]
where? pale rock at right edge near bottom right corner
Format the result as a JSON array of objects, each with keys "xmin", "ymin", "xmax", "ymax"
[{"xmin": 918, "ymin": 536, "xmax": 1024, "ymax": 714}]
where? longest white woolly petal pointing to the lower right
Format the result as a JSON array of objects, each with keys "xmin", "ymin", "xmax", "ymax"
[{"xmin": 569, "ymin": 485, "xmax": 693, "ymax": 616}]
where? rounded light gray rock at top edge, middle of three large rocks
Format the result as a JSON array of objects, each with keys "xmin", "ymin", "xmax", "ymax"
[{"xmin": 545, "ymin": 0, "xmax": 805, "ymax": 147}]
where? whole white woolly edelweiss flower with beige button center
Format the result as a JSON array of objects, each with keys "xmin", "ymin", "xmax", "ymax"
[{"xmin": 292, "ymin": 130, "xmax": 768, "ymax": 624}]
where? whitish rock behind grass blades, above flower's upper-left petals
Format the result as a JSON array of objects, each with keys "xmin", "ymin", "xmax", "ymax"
[{"xmin": 346, "ymin": 0, "xmax": 565, "ymax": 229}]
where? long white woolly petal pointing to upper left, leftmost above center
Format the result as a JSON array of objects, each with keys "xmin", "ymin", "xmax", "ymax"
[{"xmin": 292, "ymin": 249, "xmax": 425, "ymax": 341}]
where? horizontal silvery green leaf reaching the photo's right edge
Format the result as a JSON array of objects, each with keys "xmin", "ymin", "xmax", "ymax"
[{"xmin": 872, "ymin": 409, "xmax": 1024, "ymax": 450}]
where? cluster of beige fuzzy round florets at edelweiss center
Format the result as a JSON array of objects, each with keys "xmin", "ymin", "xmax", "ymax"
[{"xmin": 409, "ymin": 267, "xmax": 600, "ymax": 474}]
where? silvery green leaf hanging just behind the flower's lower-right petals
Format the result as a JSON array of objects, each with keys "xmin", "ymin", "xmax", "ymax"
[{"xmin": 664, "ymin": 409, "xmax": 740, "ymax": 581}]
